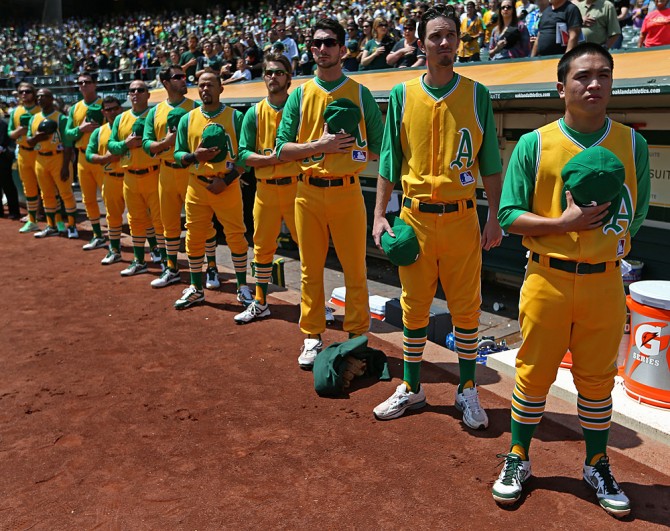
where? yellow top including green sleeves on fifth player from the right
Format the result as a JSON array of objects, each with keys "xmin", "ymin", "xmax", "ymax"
[{"xmin": 175, "ymin": 104, "xmax": 243, "ymax": 176}]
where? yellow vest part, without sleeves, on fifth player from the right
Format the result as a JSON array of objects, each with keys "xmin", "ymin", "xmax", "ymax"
[{"xmin": 186, "ymin": 105, "xmax": 239, "ymax": 176}]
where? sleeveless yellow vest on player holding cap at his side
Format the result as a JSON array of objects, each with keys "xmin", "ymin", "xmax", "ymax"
[{"xmin": 400, "ymin": 76, "xmax": 484, "ymax": 203}]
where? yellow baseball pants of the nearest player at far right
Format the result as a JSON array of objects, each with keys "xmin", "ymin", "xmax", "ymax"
[{"xmin": 516, "ymin": 257, "xmax": 626, "ymax": 399}]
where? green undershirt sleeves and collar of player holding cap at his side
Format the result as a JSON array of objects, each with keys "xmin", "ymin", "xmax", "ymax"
[{"xmin": 379, "ymin": 75, "xmax": 502, "ymax": 183}]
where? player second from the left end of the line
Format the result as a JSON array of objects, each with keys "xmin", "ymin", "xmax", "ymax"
[{"xmin": 27, "ymin": 88, "xmax": 79, "ymax": 238}]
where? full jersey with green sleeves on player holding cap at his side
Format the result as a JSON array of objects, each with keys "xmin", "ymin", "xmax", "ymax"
[{"xmin": 379, "ymin": 74, "xmax": 502, "ymax": 203}]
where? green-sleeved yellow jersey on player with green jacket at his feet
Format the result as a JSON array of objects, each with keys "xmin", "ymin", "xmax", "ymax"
[{"xmin": 277, "ymin": 76, "xmax": 384, "ymax": 177}]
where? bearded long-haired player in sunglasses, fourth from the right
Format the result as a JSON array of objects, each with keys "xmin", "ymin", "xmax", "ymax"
[{"xmin": 235, "ymin": 54, "xmax": 300, "ymax": 323}]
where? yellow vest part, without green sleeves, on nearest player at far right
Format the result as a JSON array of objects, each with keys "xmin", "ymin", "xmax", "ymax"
[{"xmin": 523, "ymin": 118, "xmax": 637, "ymax": 264}]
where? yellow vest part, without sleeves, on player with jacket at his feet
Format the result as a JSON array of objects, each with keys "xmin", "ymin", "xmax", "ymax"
[{"xmin": 296, "ymin": 78, "xmax": 368, "ymax": 177}]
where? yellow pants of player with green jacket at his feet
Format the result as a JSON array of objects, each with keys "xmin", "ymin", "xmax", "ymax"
[{"xmin": 295, "ymin": 177, "xmax": 370, "ymax": 335}]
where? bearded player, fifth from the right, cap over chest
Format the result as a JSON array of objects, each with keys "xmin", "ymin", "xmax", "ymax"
[{"xmin": 174, "ymin": 72, "xmax": 254, "ymax": 310}]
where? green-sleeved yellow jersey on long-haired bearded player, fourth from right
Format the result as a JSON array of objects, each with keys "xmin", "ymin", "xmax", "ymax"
[{"xmin": 239, "ymin": 98, "xmax": 301, "ymax": 180}]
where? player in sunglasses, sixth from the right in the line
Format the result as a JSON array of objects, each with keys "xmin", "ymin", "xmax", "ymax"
[{"xmin": 142, "ymin": 65, "xmax": 201, "ymax": 289}]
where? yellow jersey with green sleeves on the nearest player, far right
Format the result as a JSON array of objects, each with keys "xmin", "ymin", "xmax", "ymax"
[{"xmin": 498, "ymin": 118, "xmax": 651, "ymax": 263}]
